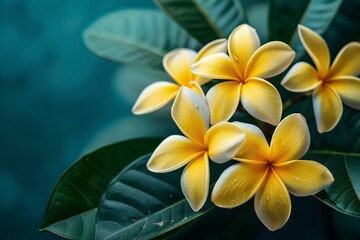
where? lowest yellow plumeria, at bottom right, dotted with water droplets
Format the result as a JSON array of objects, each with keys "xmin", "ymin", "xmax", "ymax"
[{"xmin": 211, "ymin": 114, "xmax": 334, "ymax": 231}]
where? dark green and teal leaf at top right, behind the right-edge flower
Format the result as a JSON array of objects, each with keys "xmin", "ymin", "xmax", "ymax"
[{"xmin": 270, "ymin": 0, "xmax": 343, "ymax": 59}]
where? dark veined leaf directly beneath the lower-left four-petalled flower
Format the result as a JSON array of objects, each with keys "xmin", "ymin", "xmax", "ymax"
[{"xmin": 96, "ymin": 155, "xmax": 218, "ymax": 240}]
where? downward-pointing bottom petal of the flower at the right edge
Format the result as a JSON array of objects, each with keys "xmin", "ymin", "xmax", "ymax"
[{"xmin": 312, "ymin": 85, "xmax": 343, "ymax": 133}]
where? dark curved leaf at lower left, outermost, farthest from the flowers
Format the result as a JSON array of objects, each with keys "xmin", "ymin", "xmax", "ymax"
[{"xmin": 40, "ymin": 138, "xmax": 161, "ymax": 239}]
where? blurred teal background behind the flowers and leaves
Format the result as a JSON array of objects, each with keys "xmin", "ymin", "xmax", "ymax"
[{"xmin": 0, "ymin": 0, "xmax": 359, "ymax": 239}]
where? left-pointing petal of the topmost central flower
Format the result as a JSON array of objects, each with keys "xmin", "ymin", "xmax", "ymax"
[{"xmin": 191, "ymin": 53, "xmax": 239, "ymax": 80}]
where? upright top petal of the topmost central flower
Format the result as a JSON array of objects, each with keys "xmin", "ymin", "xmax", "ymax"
[{"xmin": 228, "ymin": 24, "xmax": 260, "ymax": 77}]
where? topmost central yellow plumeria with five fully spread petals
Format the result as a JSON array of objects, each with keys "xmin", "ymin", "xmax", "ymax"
[{"xmin": 191, "ymin": 24, "xmax": 295, "ymax": 125}]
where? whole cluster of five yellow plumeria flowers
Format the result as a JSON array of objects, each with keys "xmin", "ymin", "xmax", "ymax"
[{"xmin": 133, "ymin": 24, "xmax": 360, "ymax": 230}]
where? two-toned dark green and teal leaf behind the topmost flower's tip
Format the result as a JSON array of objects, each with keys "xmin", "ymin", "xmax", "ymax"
[{"xmin": 155, "ymin": 0, "xmax": 245, "ymax": 44}]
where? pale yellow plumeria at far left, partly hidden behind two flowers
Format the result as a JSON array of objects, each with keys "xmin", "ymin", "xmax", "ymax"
[{"xmin": 132, "ymin": 39, "xmax": 227, "ymax": 115}]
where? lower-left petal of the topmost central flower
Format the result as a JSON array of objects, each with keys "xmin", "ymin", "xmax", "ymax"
[{"xmin": 206, "ymin": 81, "xmax": 242, "ymax": 125}]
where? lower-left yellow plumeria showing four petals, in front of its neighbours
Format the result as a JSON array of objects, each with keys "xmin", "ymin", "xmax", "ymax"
[{"xmin": 147, "ymin": 87, "xmax": 245, "ymax": 211}]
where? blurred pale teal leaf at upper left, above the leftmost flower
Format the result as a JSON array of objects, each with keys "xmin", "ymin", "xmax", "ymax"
[{"xmin": 83, "ymin": 9, "xmax": 199, "ymax": 69}]
